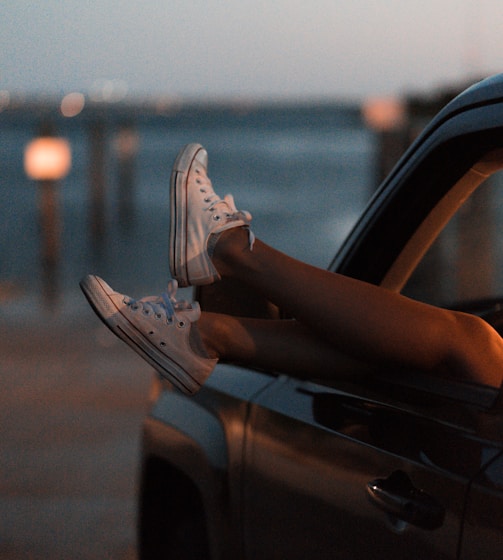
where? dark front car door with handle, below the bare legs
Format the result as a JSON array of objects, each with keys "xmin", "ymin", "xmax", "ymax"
[{"xmin": 243, "ymin": 377, "xmax": 501, "ymax": 560}]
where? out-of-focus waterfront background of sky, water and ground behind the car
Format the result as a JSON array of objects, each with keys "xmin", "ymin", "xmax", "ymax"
[{"xmin": 0, "ymin": 0, "xmax": 503, "ymax": 559}]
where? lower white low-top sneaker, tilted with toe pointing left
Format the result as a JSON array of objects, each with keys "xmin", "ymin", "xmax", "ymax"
[{"xmin": 80, "ymin": 275, "xmax": 218, "ymax": 395}]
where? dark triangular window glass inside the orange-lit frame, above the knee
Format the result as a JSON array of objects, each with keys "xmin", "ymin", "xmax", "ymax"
[{"xmin": 402, "ymin": 171, "xmax": 503, "ymax": 314}]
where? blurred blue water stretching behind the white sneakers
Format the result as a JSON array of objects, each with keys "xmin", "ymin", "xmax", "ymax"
[{"xmin": 0, "ymin": 103, "xmax": 376, "ymax": 312}]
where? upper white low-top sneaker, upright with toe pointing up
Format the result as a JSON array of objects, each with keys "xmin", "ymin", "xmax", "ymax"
[{"xmin": 170, "ymin": 144, "xmax": 254, "ymax": 286}]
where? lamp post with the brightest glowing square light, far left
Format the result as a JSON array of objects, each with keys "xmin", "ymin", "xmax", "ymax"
[{"xmin": 24, "ymin": 136, "xmax": 72, "ymax": 288}]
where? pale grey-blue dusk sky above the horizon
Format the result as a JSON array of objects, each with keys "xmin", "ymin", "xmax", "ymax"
[{"xmin": 0, "ymin": 0, "xmax": 503, "ymax": 100}]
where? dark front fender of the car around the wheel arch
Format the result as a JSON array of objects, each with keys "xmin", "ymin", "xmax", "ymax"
[{"xmin": 139, "ymin": 364, "xmax": 276, "ymax": 559}]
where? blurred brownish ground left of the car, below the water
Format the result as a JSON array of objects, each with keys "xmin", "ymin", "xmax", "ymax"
[{"xmin": 0, "ymin": 297, "xmax": 153, "ymax": 560}]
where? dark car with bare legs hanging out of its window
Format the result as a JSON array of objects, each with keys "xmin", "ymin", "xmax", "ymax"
[{"xmin": 138, "ymin": 75, "xmax": 503, "ymax": 560}]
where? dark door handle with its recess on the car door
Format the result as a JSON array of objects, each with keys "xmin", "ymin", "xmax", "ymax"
[{"xmin": 367, "ymin": 471, "xmax": 445, "ymax": 530}]
